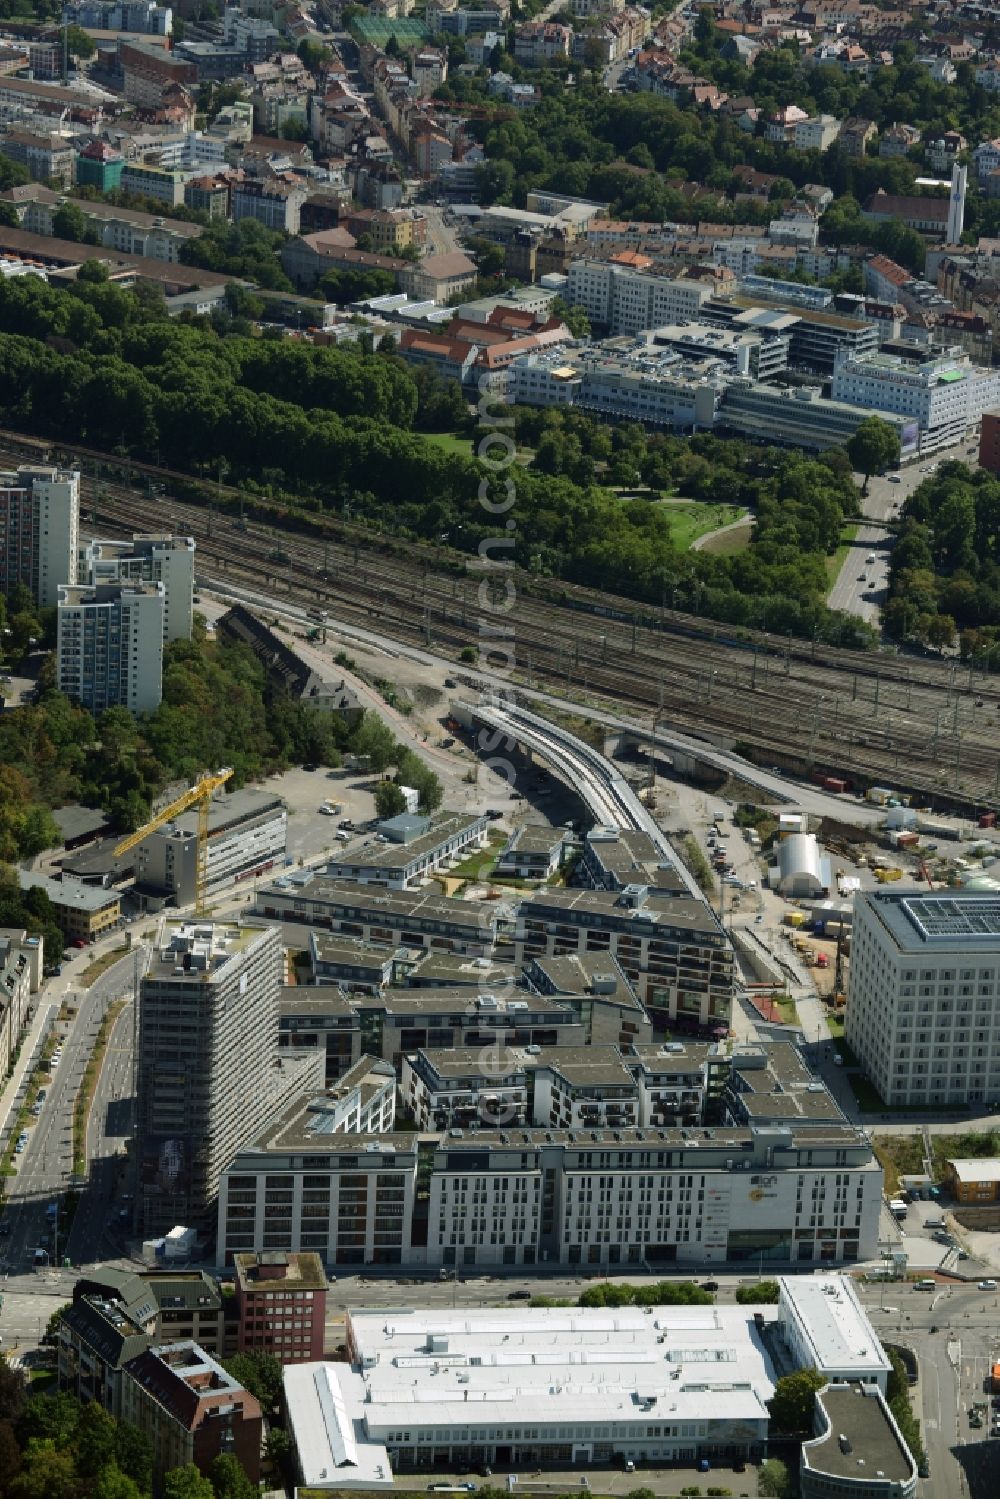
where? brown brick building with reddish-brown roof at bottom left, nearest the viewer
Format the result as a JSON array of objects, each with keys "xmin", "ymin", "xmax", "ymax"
[{"xmin": 121, "ymin": 1340, "xmax": 264, "ymax": 1487}]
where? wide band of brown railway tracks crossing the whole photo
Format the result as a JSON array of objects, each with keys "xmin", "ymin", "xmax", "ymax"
[{"xmin": 0, "ymin": 432, "xmax": 1000, "ymax": 806}]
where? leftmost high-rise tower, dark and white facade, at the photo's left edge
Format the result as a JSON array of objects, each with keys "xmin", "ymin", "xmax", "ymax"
[{"xmin": 0, "ymin": 465, "xmax": 79, "ymax": 609}]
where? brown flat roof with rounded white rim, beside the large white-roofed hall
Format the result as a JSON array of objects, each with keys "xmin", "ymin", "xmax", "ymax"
[{"xmin": 802, "ymin": 1384, "xmax": 915, "ymax": 1484}]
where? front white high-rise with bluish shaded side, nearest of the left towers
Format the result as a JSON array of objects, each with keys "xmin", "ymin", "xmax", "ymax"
[{"xmin": 57, "ymin": 583, "xmax": 163, "ymax": 714}]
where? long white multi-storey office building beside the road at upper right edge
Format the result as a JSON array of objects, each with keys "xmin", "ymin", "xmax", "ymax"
[{"xmin": 831, "ymin": 348, "xmax": 1000, "ymax": 453}]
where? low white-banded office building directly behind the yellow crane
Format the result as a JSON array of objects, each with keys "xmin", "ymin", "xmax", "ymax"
[{"xmin": 135, "ymin": 787, "xmax": 288, "ymax": 908}]
